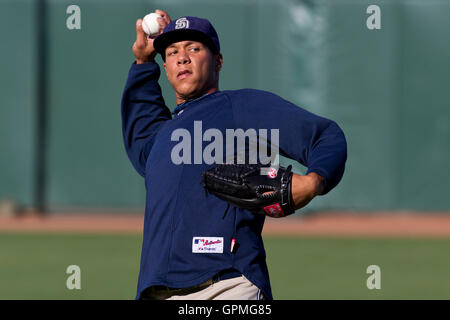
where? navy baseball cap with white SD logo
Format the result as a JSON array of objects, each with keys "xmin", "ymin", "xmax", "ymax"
[{"xmin": 153, "ymin": 16, "xmax": 220, "ymax": 60}]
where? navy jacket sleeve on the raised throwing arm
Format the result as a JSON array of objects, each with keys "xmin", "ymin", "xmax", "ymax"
[{"xmin": 122, "ymin": 62, "xmax": 171, "ymax": 176}]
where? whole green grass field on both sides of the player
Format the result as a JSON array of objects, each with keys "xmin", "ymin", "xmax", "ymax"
[{"xmin": 0, "ymin": 233, "xmax": 450, "ymax": 299}]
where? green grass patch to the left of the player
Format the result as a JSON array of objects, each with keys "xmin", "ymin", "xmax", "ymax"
[{"xmin": 0, "ymin": 233, "xmax": 141, "ymax": 300}]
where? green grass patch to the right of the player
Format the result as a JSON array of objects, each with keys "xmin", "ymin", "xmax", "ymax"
[{"xmin": 265, "ymin": 238, "xmax": 450, "ymax": 300}]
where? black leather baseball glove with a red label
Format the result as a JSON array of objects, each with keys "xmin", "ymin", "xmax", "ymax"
[{"xmin": 203, "ymin": 164, "xmax": 295, "ymax": 218}]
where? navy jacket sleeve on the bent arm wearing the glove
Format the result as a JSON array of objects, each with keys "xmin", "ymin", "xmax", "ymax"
[{"xmin": 232, "ymin": 90, "xmax": 347, "ymax": 194}]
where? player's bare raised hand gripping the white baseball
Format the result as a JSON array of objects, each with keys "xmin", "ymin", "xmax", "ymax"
[{"xmin": 133, "ymin": 10, "xmax": 170, "ymax": 64}]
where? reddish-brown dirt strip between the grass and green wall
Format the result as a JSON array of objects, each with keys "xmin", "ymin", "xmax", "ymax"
[{"xmin": 0, "ymin": 212, "xmax": 450, "ymax": 237}]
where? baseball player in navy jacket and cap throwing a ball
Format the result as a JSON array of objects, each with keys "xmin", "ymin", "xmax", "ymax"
[{"xmin": 122, "ymin": 10, "xmax": 347, "ymax": 300}]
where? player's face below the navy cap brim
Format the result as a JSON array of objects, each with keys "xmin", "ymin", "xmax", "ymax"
[{"xmin": 164, "ymin": 40, "xmax": 222, "ymax": 103}]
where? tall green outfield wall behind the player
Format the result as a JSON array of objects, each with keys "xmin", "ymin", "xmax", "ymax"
[{"xmin": 0, "ymin": 0, "xmax": 450, "ymax": 211}]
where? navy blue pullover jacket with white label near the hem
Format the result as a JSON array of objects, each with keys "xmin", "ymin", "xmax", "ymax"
[{"xmin": 122, "ymin": 62, "xmax": 347, "ymax": 299}]
